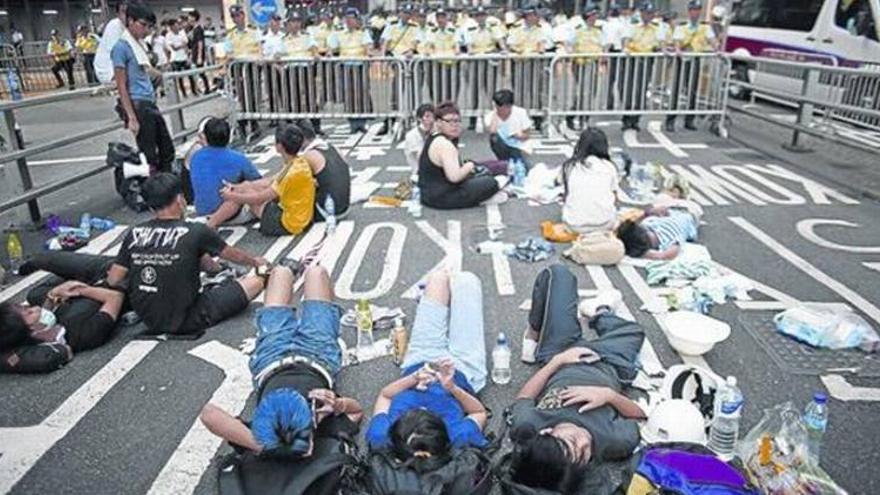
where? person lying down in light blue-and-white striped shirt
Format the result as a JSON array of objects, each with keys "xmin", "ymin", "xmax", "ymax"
[{"xmin": 617, "ymin": 206, "xmax": 698, "ymax": 260}]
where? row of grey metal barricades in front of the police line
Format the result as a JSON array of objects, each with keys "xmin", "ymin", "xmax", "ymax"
[{"xmin": 227, "ymin": 53, "xmax": 730, "ymax": 132}]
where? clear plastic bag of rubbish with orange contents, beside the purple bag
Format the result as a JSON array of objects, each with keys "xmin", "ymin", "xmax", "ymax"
[{"xmin": 736, "ymin": 402, "xmax": 847, "ymax": 495}]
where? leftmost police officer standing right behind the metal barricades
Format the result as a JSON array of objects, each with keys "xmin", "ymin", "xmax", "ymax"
[{"xmin": 226, "ymin": 5, "xmax": 262, "ymax": 137}]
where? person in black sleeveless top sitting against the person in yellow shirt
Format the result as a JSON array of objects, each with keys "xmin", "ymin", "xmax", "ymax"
[{"xmin": 296, "ymin": 120, "xmax": 351, "ymax": 221}]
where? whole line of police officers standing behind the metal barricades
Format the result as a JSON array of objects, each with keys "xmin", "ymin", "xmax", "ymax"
[{"xmin": 221, "ymin": 0, "xmax": 721, "ymax": 133}]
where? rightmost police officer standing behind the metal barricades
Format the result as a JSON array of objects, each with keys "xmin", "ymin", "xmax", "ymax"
[{"xmin": 666, "ymin": 0, "xmax": 718, "ymax": 132}]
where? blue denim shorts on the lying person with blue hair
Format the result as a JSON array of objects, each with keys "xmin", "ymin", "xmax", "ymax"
[{"xmin": 250, "ymin": 300, "xmax": 342, "ymax": 377}]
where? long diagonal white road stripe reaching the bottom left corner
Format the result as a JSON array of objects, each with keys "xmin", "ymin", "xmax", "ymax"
[{"xmin": 0, "ymin": 340, "xmax": 158, "ymax": 493}]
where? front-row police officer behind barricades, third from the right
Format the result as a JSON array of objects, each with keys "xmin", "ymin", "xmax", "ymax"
[{"xmin": 565, "ymin": 3, "xmax": 608, "ymax": 130}]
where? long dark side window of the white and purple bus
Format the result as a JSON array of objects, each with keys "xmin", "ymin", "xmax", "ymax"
[{"xmin": 731, "ymin": 0, "xmax": 824, "ymax": 31}]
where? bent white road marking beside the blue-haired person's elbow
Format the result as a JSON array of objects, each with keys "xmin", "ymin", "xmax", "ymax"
[{"xmin": 147, "ymin": 340, "xmax": 252, "ymax": 495}]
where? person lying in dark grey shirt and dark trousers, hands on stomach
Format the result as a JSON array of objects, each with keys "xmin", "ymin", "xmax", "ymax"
[{"xmin": 510, "ymin": 264, "xmax": 645, "ymax": 493}]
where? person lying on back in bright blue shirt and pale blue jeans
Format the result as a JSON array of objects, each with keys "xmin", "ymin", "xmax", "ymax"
[{"xmin": 366, "ymin": 272, "xmax": 488, "ymax": 473}]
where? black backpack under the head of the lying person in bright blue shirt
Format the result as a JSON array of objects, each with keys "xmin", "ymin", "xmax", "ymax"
[{"xmin": 365, "ymin": 447, "xmax": 494, "ymax": 495}]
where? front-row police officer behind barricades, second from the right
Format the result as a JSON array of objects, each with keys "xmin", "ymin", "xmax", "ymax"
[{"xmin": 622, "ymin": 2, "xmax": 663, "ymax": 131}]
